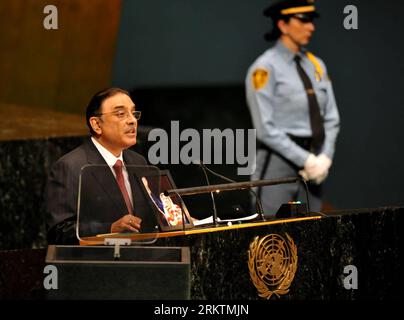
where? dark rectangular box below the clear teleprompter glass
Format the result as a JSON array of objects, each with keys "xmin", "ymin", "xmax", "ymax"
[{"xmin": 46, "ymin": 245, "xmax": 191, "ymax": 300}]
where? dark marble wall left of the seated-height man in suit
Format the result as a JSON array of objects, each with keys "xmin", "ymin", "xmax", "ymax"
[{"xmin": 0, "ymin": 137, "xmax": 82, "ymax": 249}]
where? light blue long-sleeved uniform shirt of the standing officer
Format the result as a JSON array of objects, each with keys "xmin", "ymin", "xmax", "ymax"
[{"xmin": 246, "ymin": 40, "xmax": 339, "ymax": 167}]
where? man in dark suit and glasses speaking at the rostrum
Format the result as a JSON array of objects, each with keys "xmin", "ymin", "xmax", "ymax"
[{"xmin": 46, "ymin": 88, "xmax": 155, "ymax": 244}]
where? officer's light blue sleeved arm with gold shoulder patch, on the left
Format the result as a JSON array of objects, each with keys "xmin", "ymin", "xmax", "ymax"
[{"xmin": 246, "ymin": 66, "xmax": 310, "ymax": 167}]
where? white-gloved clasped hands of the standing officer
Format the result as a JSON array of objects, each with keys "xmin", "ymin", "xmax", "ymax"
[{"xmin": 299, "ymin": 154, "xmax": 332, "ymax": 184}]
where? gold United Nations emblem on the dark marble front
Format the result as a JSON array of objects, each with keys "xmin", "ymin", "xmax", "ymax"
[{"xmin": 248, "ymin": 233, "xmax": 297, "ymax": 299}]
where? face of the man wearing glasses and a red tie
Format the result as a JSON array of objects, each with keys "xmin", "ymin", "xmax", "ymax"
[{"xmin": 96, "ymin": 93, "xmax": 137, "ymax": 155}]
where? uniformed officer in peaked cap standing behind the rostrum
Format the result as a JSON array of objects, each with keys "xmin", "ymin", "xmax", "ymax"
[{"xmin": 246, "ymin": 0, "xmax": 339, "ymax": 216}]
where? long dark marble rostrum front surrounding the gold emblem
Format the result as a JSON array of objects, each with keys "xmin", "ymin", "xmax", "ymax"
[{"xmin": 0, "ymin": 207, "xmax": 404, "ymax": 301}]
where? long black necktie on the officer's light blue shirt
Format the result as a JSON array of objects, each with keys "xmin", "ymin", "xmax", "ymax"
[{"xmin": 294, "ymin": 55, "xmax": 325, "ymax": 153}]
